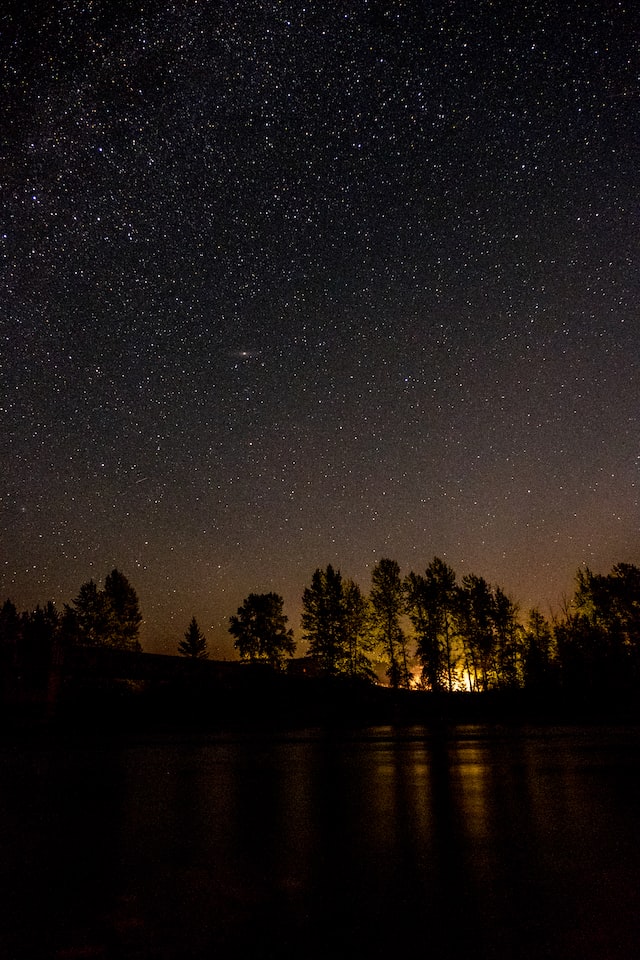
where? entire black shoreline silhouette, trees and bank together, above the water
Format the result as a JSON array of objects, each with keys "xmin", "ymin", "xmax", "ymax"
[{"xmin": 0, "ymin": 557, "xmax": 640, "ymax": 725}]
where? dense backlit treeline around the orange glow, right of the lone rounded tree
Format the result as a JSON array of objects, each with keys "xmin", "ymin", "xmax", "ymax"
[{"xmin": 288, "ymin": 557, "xmax": 640, "ymax": 693}]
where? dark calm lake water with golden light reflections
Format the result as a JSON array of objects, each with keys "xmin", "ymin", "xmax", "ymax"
[{"xmin": 0, "ymin": 726, "xmax": 640, "ymax": 960}]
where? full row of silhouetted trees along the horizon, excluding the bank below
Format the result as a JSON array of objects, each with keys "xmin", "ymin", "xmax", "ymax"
[{"xmin": 0, "ymin": 557, "xmax": 640, "ymax": 695}]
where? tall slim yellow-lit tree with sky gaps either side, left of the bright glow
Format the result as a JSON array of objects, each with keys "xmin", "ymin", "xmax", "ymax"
[{"xmin": 369, "ymin": 557, "xmax": 409, "ymax": 687}]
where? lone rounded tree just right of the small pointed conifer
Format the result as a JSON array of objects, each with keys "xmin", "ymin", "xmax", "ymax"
[{"xmin": 229, "ymin": 593, "xmax": 296, "ymax": 669}]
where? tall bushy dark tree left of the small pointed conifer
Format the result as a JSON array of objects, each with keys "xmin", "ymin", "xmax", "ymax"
[{"xmin": 63, "ymin": 569, "xmax": 142, "ymax": 651}]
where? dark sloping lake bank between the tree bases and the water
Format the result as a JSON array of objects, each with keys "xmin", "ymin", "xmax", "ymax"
[{"xmin": 5, "ymin": 648, "xmax": 640, "ymax": 735}]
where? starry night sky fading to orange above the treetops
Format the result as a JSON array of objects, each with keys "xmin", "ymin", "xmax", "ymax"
[{"xmin": 0, "ymin": 0, "xmax": 640, "ymax": 656}]
